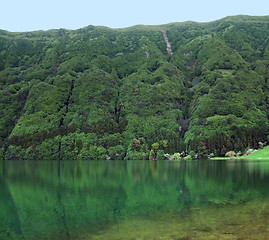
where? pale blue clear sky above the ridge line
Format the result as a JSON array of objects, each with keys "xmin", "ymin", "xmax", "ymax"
[{"xmin": 0, "ymin": 0, "xmax": 269, "ymax": 32}]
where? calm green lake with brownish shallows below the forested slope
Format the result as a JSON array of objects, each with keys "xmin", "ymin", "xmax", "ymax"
[{"xmin": 0, "ymin": 160, "xmax": 269, "ymax": 240}]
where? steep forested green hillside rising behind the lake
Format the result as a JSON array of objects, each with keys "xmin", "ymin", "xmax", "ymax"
[{"xmin": 0, "ymin": 16, "xmax": 269, "ymax": 159}]
